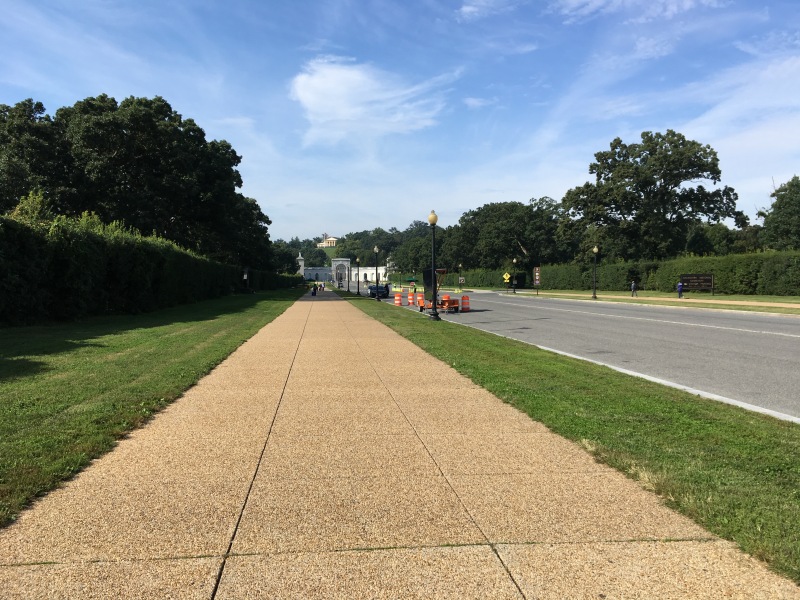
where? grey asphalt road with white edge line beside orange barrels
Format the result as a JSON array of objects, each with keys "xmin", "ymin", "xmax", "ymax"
[{"xmin": 428, "ymin": 293, "xmax": 800, "ymax": 422}]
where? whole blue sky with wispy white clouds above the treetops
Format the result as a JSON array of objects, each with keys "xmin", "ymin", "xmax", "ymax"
[{"xmin": 0, "ymin": 0, "xmax": 800, "ymax": 239}]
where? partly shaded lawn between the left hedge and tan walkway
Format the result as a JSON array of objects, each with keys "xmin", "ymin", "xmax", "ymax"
[{"xmin": 0, "ymin": 288, "xmax": 305, "ymax": 526}]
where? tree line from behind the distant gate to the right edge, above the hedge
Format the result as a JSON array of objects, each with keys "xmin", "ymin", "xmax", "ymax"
[{"xmin": 275, "ymin": 130, "xmax": 800, "ymax": 273}]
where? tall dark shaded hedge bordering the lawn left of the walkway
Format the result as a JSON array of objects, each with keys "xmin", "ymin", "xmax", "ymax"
[{"xmin": 0, "ymin": 215, "xmax": 301, "ymax": 324}]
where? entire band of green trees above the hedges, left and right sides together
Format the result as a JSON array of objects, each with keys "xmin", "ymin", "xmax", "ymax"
[{"xmin": 0, "ymin": 94, "xmax": 800, "ymax": 273}]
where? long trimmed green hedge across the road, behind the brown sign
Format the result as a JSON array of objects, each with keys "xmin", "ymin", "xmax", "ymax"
[{"xmin": 392, "ymin": 251, "xmax": 800, "ymax": 296}]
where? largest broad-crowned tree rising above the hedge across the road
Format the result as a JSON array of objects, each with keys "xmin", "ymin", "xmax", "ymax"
[{"xmin": 562, "ymin": 129, "xmax": 747, "ymax": 259}]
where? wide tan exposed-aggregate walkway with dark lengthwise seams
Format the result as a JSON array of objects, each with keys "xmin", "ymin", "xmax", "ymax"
[{"xmin": 0, "ymin": 293, "xmax": 800, "ymax": 599}]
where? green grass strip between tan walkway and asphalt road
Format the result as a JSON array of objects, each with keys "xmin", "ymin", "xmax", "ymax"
[{"xmin": 343, "ymin": 294, "xmax": 800, "ymax": 584}]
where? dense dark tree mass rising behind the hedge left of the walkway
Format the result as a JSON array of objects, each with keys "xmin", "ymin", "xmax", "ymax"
[{"xmin": 0, "ymin": 94, "xmax": 273, "ymax": 268}]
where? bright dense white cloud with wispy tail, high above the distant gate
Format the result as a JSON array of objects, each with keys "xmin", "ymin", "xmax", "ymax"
[{"xmin": 290, "ymin": 56, "xmax": 459, "ymax": 145}]
